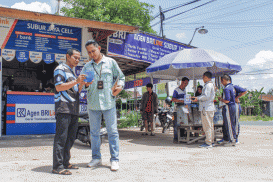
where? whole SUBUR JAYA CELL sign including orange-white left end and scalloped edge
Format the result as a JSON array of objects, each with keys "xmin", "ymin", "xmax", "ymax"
[{"xmin": 0, "ymin": 17, "xmax": 82, "ymax": 64}]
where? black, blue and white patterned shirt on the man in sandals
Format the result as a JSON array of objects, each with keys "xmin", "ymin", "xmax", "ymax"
[{"xmin": 54, "ymin": 63, "xmax": 79, "ymax": 115}]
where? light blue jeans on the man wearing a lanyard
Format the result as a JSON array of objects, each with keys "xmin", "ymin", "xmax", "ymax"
[{"xmin": 88, "ymin": 107, "xmax": 119, "ymax": 162}]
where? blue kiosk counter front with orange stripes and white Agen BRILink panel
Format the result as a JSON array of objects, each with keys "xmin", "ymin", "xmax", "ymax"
[{"xmin": 6, "ymin": 91, "xmax": 56, "ymax": 135}]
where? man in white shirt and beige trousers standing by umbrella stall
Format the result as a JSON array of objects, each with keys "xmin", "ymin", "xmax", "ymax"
[{"xmin": 192, "ymin": 71, "xmax": 215, "ymax": 148}]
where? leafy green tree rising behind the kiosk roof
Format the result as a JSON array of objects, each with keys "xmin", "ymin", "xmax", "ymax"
[{"xmin": 61, "ymin": 0, "xmax": 156, "ymax": 33}]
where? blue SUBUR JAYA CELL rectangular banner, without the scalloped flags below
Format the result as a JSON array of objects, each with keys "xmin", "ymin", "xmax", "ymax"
[{"xmin": 5, "ymin": 20, "xmax": 82, "ymax": 54}]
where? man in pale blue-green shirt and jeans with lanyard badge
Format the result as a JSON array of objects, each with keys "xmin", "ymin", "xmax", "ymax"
[{"xmin": 81, "ymin": 40, "xmax": 125, "ymax": 171}]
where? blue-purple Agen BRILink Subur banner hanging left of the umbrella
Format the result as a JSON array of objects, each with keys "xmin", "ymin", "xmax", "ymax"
[{"xmin": 108, "ymin": 32, "xmax": 190, "ymax": 63}]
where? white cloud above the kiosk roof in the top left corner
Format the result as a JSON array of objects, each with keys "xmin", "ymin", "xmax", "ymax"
[{"xmin": 11, "ymin": 1, "xmax": 51, "ymax": 13}]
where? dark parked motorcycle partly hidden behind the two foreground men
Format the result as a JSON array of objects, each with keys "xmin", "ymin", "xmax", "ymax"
[{"xmin": 76, "ymin": 113, "xmax": 107, "ymax": 146}]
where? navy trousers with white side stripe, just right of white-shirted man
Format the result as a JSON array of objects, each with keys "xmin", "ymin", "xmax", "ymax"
[{"xmin": 222, "ymin": 105, "xmax": 237, "ymax": 142}]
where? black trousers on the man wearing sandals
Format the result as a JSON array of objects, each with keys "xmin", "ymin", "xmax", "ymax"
[{"xmin": 53, "ymin": 114, "xmax": 79, "ymax": 170}]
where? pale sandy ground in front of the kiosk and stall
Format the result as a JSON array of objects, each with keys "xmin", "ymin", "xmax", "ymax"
[{"xmin": 0, "ymin": 123, "xmax": 273, "ymax": 182}]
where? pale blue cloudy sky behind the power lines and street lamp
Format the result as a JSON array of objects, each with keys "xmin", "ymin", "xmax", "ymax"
[{"xmin": 0, "ymin": 0, "xmax": 273, "ymax": 91}]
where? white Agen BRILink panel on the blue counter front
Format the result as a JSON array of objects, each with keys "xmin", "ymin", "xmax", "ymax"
[{"xmin": 15, "ymin": 104, "xmax": 56, "ymax": 123}]
